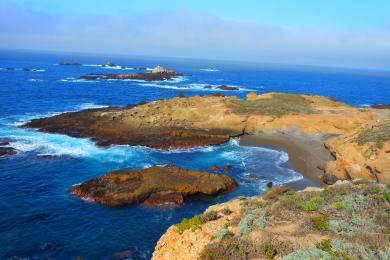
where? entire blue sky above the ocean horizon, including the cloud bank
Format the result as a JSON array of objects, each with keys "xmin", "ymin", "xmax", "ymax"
[{"xmin": 0, "ymin": 0, "xmax": 390, "ymax": 70}]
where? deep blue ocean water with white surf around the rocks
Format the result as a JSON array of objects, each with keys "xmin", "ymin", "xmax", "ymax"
[{"xmin": 0, "ymin": 51, "xmax": 390, "ymax": 259}]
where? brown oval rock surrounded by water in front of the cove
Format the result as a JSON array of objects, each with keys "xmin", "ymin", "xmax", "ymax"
[{"xmin": 70, "ymin": 166, "xmax": 236, "ymax": 207}]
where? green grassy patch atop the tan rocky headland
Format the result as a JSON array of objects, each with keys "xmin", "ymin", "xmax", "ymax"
[{"xmin": 230, "ymin": 93, "xmax": 317, "ymax": 117}]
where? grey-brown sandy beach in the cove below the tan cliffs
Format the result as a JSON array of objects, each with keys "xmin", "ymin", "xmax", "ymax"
[{"xmin": 240, "ymin": 131, "xmax": 334, "ymax": 190}]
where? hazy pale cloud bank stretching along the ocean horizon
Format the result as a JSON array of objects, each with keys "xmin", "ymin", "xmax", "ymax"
[{"xmin": 0, "ymin": 5, "xmax": 390, "ymax": 69}]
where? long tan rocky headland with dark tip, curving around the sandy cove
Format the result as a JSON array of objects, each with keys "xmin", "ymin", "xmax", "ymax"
[{"xmin": 24, "ymin": 93, "xmax": 390, "ymax": 184}]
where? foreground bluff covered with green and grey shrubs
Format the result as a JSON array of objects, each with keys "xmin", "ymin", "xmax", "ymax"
[{"xmin": 152, "ymin": 180, "xmax": 390, "ymax": 260}]
